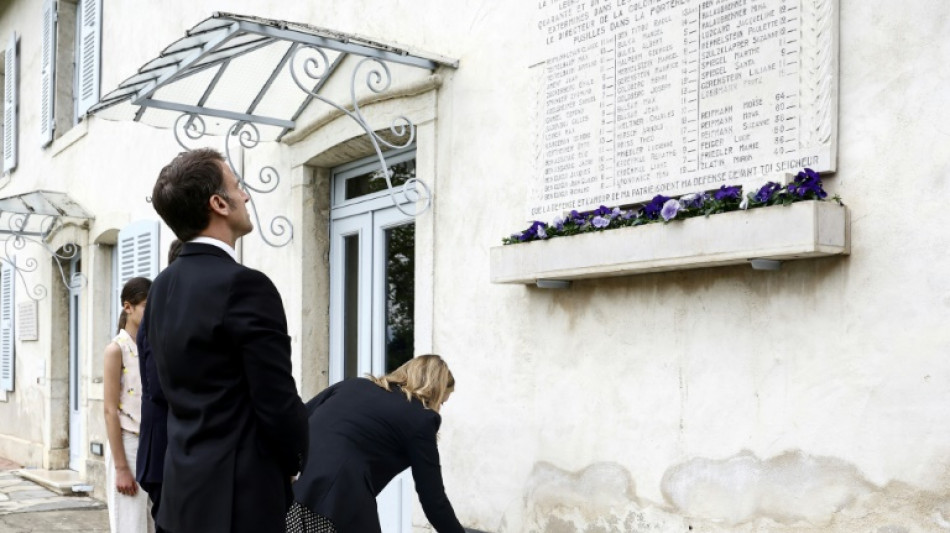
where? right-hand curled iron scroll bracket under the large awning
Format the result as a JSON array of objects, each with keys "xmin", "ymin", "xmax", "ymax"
[{"xmin": 290, "ymin": 49, "xmax": 432, "ymax": 216}]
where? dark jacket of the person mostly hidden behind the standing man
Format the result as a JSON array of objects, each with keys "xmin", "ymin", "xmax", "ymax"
[{"xmin": 135, "ymin": 314, "xmax": 168, "ymax": 487}]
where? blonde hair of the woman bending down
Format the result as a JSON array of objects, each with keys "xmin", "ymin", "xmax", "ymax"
[{"xmin": 368, "ymin": 354, "xmax": 455, "ymax": 411}]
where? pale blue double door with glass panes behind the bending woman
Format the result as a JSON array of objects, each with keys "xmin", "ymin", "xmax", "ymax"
[{"xmin": 330, "ymin": 151, "xmax": 415, "ymax": 533}]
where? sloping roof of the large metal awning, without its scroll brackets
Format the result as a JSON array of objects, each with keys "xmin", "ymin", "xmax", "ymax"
[{"xmin": 90, "ymin": 12, "xmax": 458, "ymax": 140}]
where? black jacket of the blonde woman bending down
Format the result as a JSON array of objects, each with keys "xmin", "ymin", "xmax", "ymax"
[{"xmin": 294, "ymin": 378, "xmax": 464, "ymax": 533}]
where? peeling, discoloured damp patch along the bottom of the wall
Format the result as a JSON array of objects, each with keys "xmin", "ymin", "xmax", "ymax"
[{"xmin": 498, "ymin": 451, "xmax": 950, "ymax": 533}]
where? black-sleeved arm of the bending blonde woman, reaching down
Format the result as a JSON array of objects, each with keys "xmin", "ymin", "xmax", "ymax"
[{"xmin": 409, "ymin": 412, "xmax": 465, "ymax": 533}]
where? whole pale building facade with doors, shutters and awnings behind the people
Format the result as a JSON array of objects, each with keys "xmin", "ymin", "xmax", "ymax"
[{"xmin": 0, "ymin": 0, "xmax": 950, "ymax": 532}]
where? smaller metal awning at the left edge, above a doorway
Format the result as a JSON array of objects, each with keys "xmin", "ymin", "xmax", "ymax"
[{"xmin": 0, "ymin": 191, "xmax": 93, "ymax": 239}]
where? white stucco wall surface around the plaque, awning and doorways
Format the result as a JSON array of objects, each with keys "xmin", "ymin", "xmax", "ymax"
[{"xmin": 0, "ymin": 0, "xmax": 950, "ymax": 533}]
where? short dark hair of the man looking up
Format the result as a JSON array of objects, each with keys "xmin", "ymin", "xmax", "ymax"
[{"xmin": 152, "ymin": 148, "xmax": 230, "ymax": 242}]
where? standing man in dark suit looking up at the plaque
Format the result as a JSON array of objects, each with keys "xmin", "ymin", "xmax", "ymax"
[{"xmin": 145, "ymin": 149, "xmax": 308, "ymax": 533}]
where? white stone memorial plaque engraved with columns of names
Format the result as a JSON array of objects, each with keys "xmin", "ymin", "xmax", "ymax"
[{"xmin": 529, "ymin": 0, "xmax": 838, "ymax": 219}]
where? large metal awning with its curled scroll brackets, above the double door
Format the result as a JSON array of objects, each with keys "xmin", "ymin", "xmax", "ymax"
[{"xmin": 90, "ymin": 13, "xmax": 458, "ymax": 246}]
